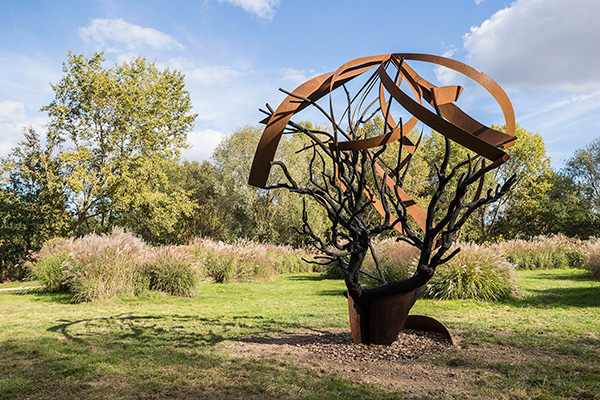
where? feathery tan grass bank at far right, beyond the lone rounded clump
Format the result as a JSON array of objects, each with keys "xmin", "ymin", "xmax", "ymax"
[{"xmin": 496, "ymin": 234, "xmax": 585, "ymax": 269}]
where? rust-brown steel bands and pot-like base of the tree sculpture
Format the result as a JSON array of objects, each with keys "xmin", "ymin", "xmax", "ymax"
[{"xmin": 248, "ymin": 53, "xmax": 516, "ymax": 344}]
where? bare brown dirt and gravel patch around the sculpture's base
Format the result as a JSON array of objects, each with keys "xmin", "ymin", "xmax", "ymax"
[{"xmin": 220, "ymin": 328, "xmax": 550, "ymax": 399}]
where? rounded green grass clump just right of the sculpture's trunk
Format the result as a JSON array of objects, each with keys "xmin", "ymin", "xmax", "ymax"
[{"xmin": 421, "ymin": 244, "xmax": 518, "ymax": 300}]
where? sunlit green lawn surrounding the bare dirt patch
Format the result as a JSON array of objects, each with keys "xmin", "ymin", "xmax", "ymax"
[{"xmin": 0, "ymin": 270, "xmax": 600, "ymax": 399}]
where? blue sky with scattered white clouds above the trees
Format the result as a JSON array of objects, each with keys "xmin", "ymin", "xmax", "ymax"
[{"xmin": 0, "ymin": 0, "xmax": 600, "ymax": 168}]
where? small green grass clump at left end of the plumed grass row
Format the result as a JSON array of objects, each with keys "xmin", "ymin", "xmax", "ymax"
[{"xmin": 29, "ymin": 253, "xmax": 72, "ymax": 293}]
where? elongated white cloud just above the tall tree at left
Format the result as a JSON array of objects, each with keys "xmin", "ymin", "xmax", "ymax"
[{"xmin": 79, "ymin": 18, "xmax": 183, "ymax": 50}]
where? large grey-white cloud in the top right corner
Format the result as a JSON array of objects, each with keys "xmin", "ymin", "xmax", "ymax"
[{"xmin": 464, "ymin": 0, "xmax": 600, "ymax": 92}]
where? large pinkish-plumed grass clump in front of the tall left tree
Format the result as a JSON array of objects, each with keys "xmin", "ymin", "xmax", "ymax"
[{"xmin": 30, "ymin": 228, "xmax": 197, "ymax": 303}]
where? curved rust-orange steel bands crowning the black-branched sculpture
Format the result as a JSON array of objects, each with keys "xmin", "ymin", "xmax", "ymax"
[{"xmin": 248, "ymin": 53, "xmax": 516, "ymax": 234}]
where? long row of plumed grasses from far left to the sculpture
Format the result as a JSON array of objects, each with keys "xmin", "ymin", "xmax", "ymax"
[{"xmin": 29, "ymin": 228, "xmax": 315, "ymax": 302}]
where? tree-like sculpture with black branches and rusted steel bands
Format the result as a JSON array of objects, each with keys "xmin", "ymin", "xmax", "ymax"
[{"xmin": 249, "ymin": 53, "xmax": 516, "ymax": 344}]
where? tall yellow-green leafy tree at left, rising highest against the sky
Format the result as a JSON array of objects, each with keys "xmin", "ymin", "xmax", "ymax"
[{"xmin": 4, "ymin": 53, "xmax": 196, "ymax": 241}]
